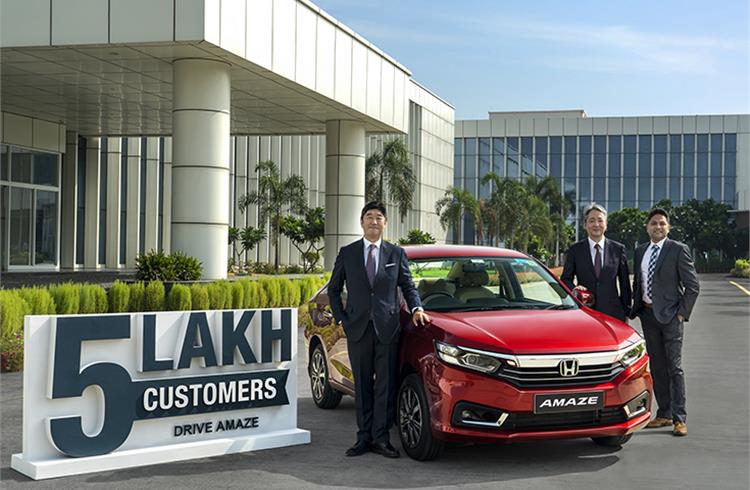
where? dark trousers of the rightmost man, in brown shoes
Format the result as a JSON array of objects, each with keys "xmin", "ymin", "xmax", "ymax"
[{"xmin": 640, "ymin": 308, "xmax": 687, "ymax": 422}]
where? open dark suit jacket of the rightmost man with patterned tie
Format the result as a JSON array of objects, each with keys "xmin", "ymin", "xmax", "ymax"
[{"xmin": 630, "ymin": 238, "xmax": 700, "ymax": 324}]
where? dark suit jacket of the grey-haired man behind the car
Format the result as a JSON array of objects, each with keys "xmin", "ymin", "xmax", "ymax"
[{"xmin": 561, "ymin": 238, "xmax": 631, "ymax": 320}]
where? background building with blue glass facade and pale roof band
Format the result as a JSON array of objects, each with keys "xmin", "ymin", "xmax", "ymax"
[{"xmin": 453, "ymin": 111, "xmax": 748, "ymax": 243}]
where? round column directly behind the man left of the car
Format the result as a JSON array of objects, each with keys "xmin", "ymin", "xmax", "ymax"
[{"xmin": 325, "ymin": 120, "xmax": 365, "ymax": 270}]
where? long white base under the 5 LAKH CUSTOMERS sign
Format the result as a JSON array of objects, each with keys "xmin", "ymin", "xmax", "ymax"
[{"xmin": 10, "ymin": 429, "xmax": 310, "ymax": 480}]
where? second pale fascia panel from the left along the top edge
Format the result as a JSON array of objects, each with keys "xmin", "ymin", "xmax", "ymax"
[{"xmin": 52, "ymin": 0, "xmax": 109, "ymax": 46}]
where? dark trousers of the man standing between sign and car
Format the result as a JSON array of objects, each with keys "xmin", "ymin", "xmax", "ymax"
[{"xmin": 347, "ymin": 322, "xmax": 398, "ymax": 443}]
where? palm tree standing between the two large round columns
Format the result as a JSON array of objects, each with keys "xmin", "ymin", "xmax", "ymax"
[{"xmin": 239, "ymin": 160, "xmax": 307, "ymax": 273}]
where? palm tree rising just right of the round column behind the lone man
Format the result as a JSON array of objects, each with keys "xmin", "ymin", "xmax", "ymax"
[{"xmin": 365, "ymin": 139, "xmax": 417, "ymax": 222}]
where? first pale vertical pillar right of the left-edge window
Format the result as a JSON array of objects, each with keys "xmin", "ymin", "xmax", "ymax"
[{"xmin": 83, "ymin": 137, "xmax": 101, "ymax": 269}]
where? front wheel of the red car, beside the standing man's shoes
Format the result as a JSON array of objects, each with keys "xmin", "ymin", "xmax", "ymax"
[{"xmin": 396, "ymin": 374, "xmax": 445, "ymax": 461}]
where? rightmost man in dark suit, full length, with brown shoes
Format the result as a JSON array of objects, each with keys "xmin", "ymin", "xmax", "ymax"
[{"xmin": 631, "ymin": 208, "xmax": 700, "ymax": 436}]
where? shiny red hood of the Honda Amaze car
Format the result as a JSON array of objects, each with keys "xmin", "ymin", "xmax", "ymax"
[{"xmin": 429, "ymin": 309, "xmax": 638, "ymax": 354}]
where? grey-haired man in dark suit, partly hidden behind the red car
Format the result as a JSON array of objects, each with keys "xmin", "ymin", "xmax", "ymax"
[{"xmin": 561, "ymin": 204, "xmax": 631, "ymax": 321}]
